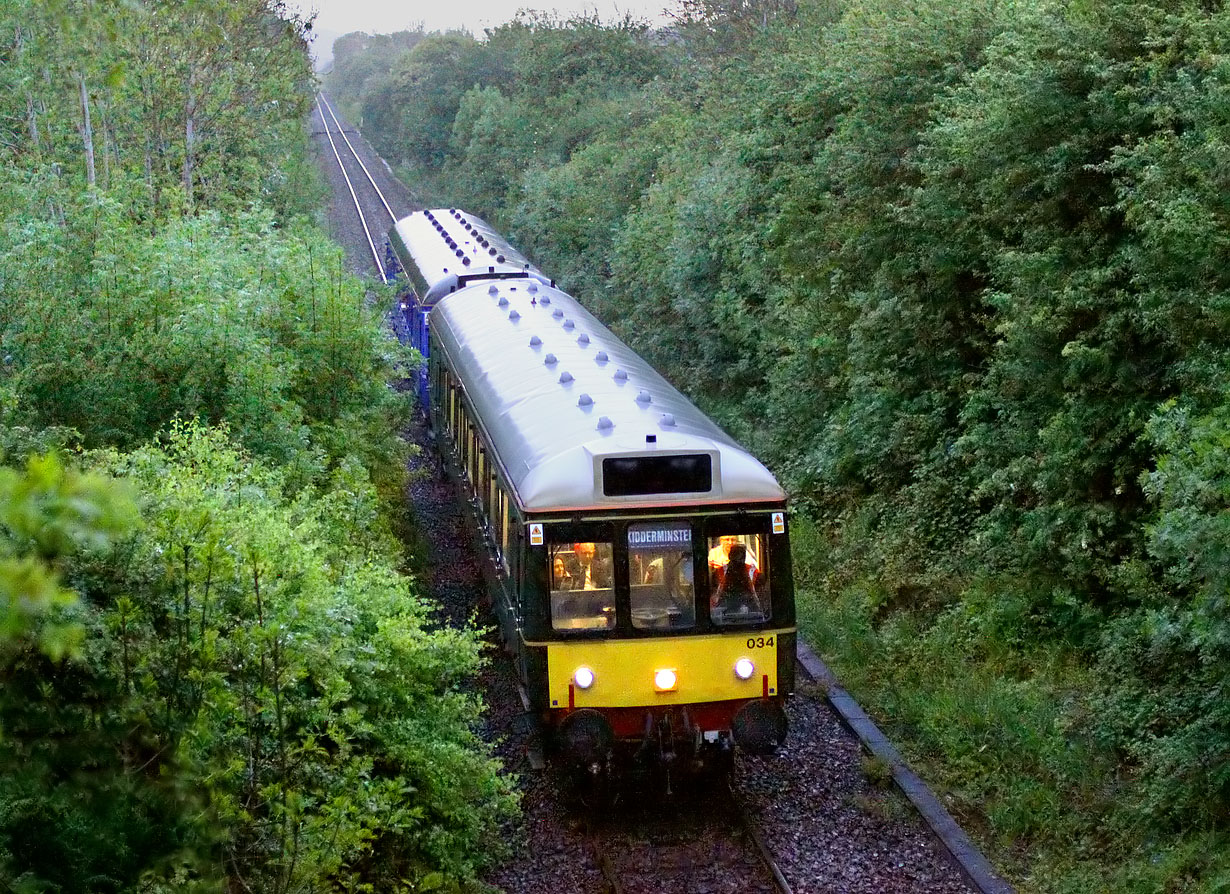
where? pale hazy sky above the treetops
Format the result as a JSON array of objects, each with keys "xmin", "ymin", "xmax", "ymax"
[{"xmin": 288, "ymin": 0, "xmax": 675, "ymax": 58}]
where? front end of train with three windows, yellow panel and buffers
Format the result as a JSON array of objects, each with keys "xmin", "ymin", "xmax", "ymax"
[{"xmin": 522, "ymin": 507, "xmax": 796, "ymax": 766}]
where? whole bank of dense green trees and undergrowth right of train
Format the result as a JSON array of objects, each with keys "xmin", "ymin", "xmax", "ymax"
[{"xmin": 338, "ymin": 0, "xmax": 1230, "ymax": 892}]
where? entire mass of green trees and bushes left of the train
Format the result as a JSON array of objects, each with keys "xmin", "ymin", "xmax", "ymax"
[{"xmin": 0, "ymin": 0, "xmax": 515, "ymax": 893}]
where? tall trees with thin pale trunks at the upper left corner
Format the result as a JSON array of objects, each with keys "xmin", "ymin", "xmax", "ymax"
[{"xmin": 0, "ymin": 0, "xmax": 311, "ymax": 215}]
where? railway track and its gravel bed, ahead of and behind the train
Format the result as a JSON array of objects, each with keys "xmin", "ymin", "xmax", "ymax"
[{"xmin": 305, "ymin": 95, "xmax": 1012, "ymax": 894}]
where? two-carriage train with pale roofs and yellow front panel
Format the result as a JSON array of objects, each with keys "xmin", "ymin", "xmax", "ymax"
[{"xmin": 389, "ymin": 209, "xmax": 796, "ymax": 772}]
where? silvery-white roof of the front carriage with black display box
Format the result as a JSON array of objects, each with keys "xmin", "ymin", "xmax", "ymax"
[{"xmin": 429, "ymin": 252, "xmax": 785, "ymax": 512}]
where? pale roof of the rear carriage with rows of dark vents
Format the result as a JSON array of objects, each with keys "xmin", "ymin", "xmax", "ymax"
[{"xmin": 389, "ymin": 208, "xmax": 550, "ymax": 305}]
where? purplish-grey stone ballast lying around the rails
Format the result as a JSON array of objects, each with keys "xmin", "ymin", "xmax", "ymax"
[{"xmin": 312, "ymin": 99, "xmax": 969, "ymax": 894}]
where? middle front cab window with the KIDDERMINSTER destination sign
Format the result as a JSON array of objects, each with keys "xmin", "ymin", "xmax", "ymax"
[{"xmin": 627, "ymin": 521, "xmax": 696, "ymax": 630}]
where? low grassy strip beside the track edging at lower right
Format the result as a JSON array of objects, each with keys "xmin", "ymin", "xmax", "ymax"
[{"xmin": 792, "ymin": 521, "xmax": 1230, "ymax": 894}]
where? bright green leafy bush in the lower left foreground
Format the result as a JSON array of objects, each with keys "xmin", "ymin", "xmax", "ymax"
[{"xmin": 0, "ymin": 424, "xmax": 513, "ymax": 890}]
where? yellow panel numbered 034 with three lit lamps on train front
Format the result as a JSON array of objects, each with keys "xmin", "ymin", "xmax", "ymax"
[{"xmin": 546, "ymin": 631, "xmax": 777, "ymax": 708}]
